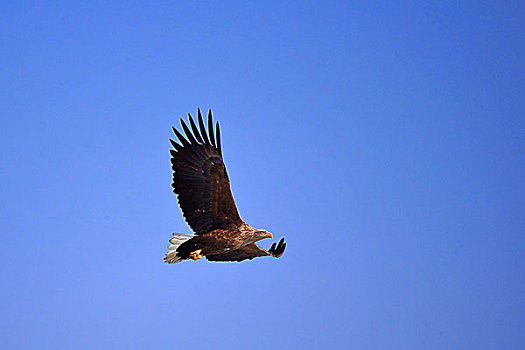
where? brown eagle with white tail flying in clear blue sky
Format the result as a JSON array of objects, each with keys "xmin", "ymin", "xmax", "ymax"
[{"xmin": 164, "ymin": 109, "xmax": 286, "ymax": 264}]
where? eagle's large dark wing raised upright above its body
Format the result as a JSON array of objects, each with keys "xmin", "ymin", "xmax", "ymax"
[{"xmin": 170, "ymin": 110, "xmax": 242, "ymax": 234}]
